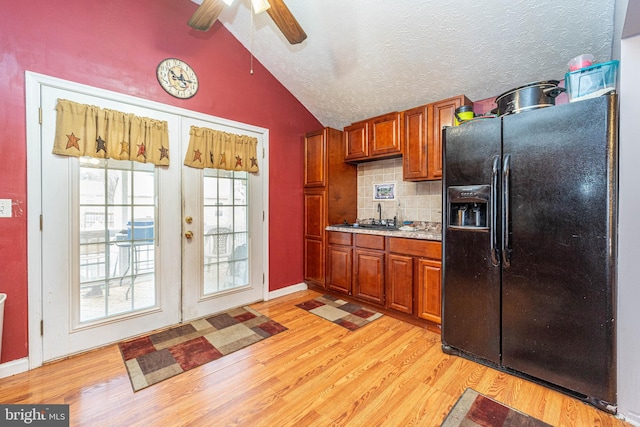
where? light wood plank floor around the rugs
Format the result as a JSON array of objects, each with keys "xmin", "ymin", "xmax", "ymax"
[{"xmin": 0, "ymin": 291, "xmax": 628, "ymax": 427}]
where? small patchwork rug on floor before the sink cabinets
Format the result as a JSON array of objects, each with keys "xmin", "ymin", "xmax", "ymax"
[{"xmin": 296, "ymin": 295, "xmax": 382, "ymax": 331}]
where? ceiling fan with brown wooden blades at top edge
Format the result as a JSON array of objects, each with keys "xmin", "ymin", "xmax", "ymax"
[{"xmin": 188, "ymin": 0, "xmax": 307, "ymax": 44}]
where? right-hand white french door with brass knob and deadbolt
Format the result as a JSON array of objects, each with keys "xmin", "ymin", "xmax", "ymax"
[{"xmin": 182, "ymin": 118, "xmax": 266, "ymax": 320}]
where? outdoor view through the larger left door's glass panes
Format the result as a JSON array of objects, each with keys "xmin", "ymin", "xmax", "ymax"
[{"xmin": 78, "ymin": 158, "xmax": 157, "ymax": 324}]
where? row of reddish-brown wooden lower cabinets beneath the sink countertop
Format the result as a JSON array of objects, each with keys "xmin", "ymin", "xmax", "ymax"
[{"xmin": 326, "ymin": 231, "xmax": 442, "ymax": 324}]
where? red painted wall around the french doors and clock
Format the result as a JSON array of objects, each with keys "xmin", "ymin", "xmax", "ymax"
[{"xmin": 0, "ymin": 0, "xmax": 321, "ymax": 362}]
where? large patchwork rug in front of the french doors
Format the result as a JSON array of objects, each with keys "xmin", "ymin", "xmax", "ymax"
[{"xmin": 118, "ymin": 307, "xmax": 287, "ymax": 391}]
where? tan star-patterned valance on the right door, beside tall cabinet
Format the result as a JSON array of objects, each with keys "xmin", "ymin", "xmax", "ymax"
[{"xmin": 184, "ymin": 126, "xmax": 258, "ymax": 173}]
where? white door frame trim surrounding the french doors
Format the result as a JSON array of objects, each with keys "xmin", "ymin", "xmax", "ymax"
[{"xmin": 25, "ymin": 71, "xmax": 269, "ymax": 369}]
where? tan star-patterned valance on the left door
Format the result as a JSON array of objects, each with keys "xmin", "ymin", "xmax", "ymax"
[{"xmin": 53, "ymin": 99, "xmax": 169, "ymax": 166}]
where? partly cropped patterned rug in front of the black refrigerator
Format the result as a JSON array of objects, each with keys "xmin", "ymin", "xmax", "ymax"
[{"xmin": 441, "ymin": 388, "xmax": 551, "ymax": 427}]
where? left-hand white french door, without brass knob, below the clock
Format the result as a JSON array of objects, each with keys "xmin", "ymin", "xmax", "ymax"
[{"xmin": 41, "ymin": 86, "xmax": 181, "ymax": 361}]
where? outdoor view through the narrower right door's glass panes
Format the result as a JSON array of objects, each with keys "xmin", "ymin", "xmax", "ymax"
[{"xmin": 203, "ymin": 169, "xmax": 249, "ymax": 295}]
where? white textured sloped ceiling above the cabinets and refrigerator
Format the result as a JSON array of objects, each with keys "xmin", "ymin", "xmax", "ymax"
[{"xmin": 193, "ymin": 0, "xmax": 615, "ymax": 129}]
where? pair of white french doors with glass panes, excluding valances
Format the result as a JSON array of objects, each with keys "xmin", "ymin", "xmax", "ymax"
[{"xmin": 27, "ymin": 75, "xmax": 268, "ymax": 366}]
